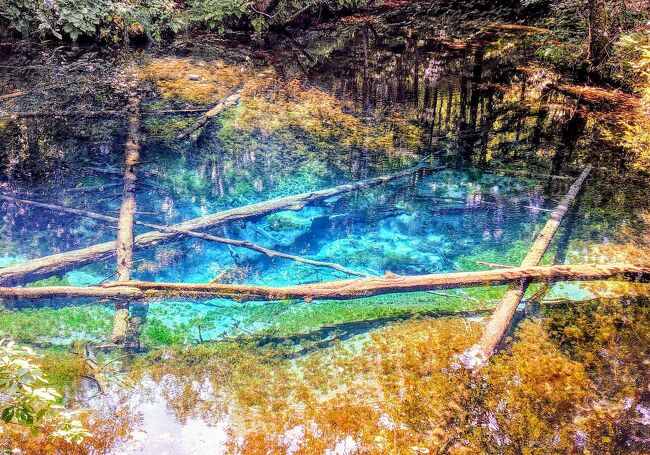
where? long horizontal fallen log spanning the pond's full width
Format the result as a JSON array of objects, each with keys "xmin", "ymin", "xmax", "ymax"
[{"xmin": 0, "ymin": 263, "xmax": 650, "ymax": 302}]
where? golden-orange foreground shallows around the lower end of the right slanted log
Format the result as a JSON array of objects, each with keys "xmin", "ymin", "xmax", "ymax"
[{"xmin": 120, "ymin": 299, "xmax": 650, "ymax": 454}]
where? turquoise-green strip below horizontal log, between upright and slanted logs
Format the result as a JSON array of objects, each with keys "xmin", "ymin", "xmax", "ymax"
[{"xmin": 119, "ymin": 287, "xmax": 494, "ymax": 348}]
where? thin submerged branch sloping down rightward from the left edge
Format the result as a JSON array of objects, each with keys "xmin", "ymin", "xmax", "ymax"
[{"xmin": 0, "ymin": 195, "xmax": 368, "ymax": 276}]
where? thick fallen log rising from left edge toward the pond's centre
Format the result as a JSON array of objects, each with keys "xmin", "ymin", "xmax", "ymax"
[{"xmin": 0, "ymin": 164, "xmax": 442, "ymax": 285}]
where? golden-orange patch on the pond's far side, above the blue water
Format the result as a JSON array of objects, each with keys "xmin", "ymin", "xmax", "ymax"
[{"xmin": 140, "ymin": 57, "xmax": 422, "ymax": 159}]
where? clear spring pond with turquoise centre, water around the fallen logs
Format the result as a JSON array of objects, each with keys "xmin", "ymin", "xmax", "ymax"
[{"xmin": 0, "ymin": 11, "xmax": 650, "ymax": 454}]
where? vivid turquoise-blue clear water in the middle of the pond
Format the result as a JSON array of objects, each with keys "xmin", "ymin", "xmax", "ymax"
[{"xmin": 3, "ymin": 158, "xmax": 552, "ymax": 341}]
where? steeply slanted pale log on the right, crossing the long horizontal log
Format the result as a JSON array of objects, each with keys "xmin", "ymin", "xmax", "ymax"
[{"xmin": 470, "ymin": 166, "xmax": 592, "ymax": 363}]
